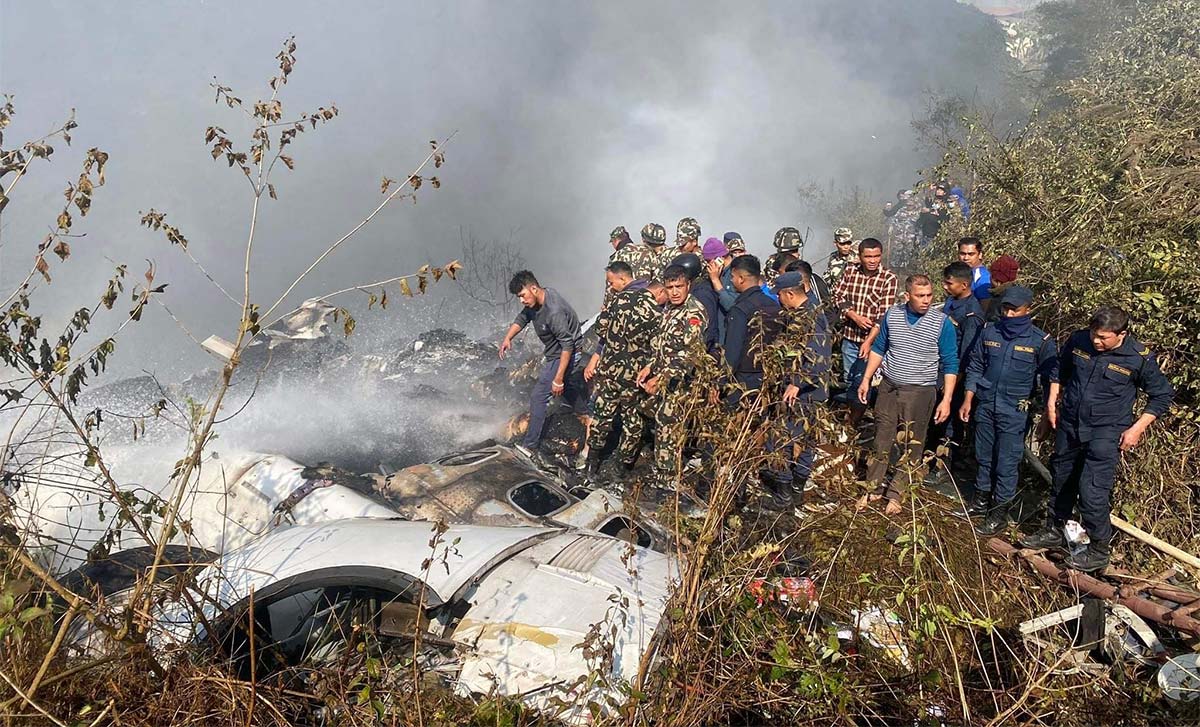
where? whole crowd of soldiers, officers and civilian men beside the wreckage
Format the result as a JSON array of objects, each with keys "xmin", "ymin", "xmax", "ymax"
[{"xmin": 499, "ymin": 217, "xmax": 1174, "ymax": 571}]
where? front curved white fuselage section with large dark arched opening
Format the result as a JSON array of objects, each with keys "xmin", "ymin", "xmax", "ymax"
[{"xmin": 74, "ymin": 518, "xmax": 678, "ymax": 722}]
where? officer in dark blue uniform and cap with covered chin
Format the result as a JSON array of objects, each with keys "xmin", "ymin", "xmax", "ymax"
[{"xmin": 959, "ymin": 286, "xmax": 1058, "ymax": 535}]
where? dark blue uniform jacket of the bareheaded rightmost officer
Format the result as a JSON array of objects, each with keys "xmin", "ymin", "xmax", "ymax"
[{"xmin": 1058, "ymin": 330, "xmax": 1175, "ymax": 438}]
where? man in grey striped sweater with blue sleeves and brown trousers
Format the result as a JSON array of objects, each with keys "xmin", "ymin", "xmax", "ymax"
[{"xmin": 858, "ymin": 275, "xmax": 959, "ymax": 515}]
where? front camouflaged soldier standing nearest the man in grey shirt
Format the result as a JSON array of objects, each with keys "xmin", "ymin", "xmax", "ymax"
[{"xmin": 583, "ymin": 260, "xmax": 662, "ymax": 476}]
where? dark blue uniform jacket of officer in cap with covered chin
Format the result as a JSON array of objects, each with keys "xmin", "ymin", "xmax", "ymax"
[{"xmin": 966, "ymin": 323, "xmax": 1058, "ymax": 409}]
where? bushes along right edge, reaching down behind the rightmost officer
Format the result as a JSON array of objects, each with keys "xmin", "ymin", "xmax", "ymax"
[{"xmin": 929, "ymin": 0, "xmax": 1200, "ymax": 551}]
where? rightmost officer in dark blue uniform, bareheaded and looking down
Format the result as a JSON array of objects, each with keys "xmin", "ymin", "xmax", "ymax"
[{"xmin": 1021, "ymin": 306, "xmax": 1175, "ymax": 572}]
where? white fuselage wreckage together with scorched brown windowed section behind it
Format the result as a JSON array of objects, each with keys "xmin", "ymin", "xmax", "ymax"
[{"xmin": 30, "ymin": 445, "xmax": 679, "ymax": 722}]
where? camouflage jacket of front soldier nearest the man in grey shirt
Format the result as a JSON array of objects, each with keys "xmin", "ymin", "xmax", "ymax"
[{"xmin": 596, "ymin": 285, "xmax": 662, "ymax": 381}]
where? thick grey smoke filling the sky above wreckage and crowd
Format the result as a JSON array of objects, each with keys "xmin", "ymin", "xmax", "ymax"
[{"xmin": 0, "ymin": 0, "xmax": 998, "ymax": 381}]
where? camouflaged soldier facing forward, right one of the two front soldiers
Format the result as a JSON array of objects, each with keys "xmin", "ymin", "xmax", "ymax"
[{"xmin": 637, "ymin": 265, "xmax": 708, "ymax": 486}]
